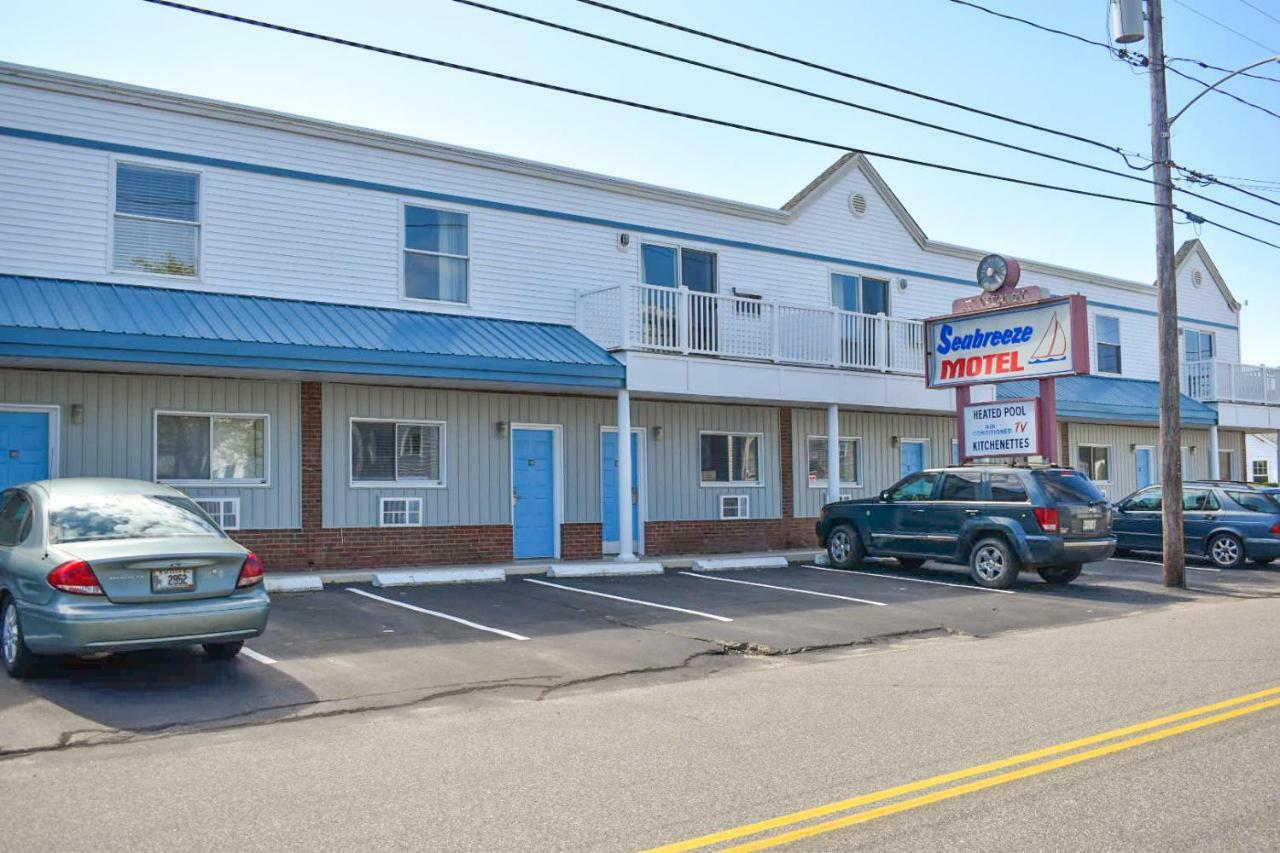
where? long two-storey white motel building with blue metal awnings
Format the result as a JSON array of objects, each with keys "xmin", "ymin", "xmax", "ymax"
[{"xmin": 0, "ymin": 64, "xmax": 1280, "ymax": 570}]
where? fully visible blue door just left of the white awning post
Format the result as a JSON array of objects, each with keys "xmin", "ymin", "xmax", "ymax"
[{"xmin": 511, "ymin": 429, "xmax": 556, "ymax": 560}]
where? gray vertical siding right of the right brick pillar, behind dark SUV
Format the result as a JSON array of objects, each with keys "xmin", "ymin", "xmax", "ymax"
[{"xmin": 791, "ymin": 409, "xmax": 956, "ymax": 517}]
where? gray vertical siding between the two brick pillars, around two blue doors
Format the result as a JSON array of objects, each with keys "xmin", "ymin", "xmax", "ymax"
[{"xmin": 324, "ymin": 383, "xmax": 781, "ymax": 528}]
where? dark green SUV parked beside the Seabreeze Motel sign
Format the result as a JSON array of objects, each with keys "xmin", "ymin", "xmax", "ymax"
[{"xmin": 818, "ymin": 465, "xmax": 1115, "ymax": 589}]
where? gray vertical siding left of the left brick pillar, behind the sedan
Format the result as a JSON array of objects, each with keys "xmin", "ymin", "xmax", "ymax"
[{"xmin": 0, "ymin": 370, "xmax": 302, "ymax": 529}]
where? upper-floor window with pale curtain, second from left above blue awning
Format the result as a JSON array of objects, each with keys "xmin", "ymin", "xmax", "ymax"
[{"xmin": 403, "ymin": 205, "xmax": 471, "ymax": 302}]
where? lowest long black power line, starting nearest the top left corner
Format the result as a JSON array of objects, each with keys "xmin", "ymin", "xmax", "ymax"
[{"xmin": 142, "ymin": 0, "xmax": 1280, "ymax": 248}]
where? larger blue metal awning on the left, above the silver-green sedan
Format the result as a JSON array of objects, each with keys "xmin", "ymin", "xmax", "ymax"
[{"xmin": 0, "ymin": 275, "xmax": 625, "ymax": 388}]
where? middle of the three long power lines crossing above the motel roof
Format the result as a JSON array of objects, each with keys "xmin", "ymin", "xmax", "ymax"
[{"xmin": 454, "ymin": 0, "xmax": 1280, "ymax": 225}]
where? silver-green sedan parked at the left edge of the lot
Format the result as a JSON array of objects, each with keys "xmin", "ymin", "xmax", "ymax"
[{"xmin": 0, "ymin": 479, "xmax": 270, "ymax": 678}]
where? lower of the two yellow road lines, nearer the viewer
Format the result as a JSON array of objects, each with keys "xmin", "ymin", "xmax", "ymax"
[{"xmin": 724, "ymin": 699, "xmax": 1280, "ymax": 853}]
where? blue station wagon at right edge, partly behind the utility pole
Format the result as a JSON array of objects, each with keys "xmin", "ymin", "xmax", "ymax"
[{"xmin": 1112, "ymin": 480, "xmax": 1280, "ymax": 569}]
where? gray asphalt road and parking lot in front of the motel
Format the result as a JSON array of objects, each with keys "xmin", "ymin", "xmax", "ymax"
[{"xmin": 0, "ymin": 562, "xmax": 1280, "ymax": 850}]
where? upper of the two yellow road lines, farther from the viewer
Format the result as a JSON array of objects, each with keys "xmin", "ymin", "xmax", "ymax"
[{"xmin": 649, "ymin": 686, "xmax": 1280, "ymax": 853}]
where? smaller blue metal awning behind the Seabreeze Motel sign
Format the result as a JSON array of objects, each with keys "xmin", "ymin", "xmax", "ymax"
[{"xmin": 996, "ymin": 375, "xmax": 1217, "ymax": 424}]
